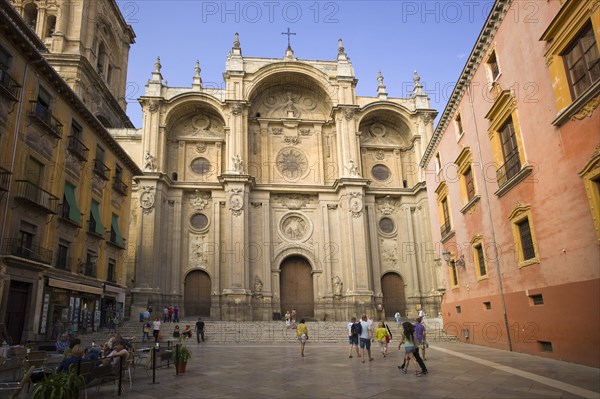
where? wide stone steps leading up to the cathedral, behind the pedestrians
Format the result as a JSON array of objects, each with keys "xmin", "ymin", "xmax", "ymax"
[{"xmin": 79, "ymin": 319, "xmax": 457, "ymax": 344}]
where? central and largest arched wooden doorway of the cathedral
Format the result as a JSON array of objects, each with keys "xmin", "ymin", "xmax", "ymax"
[{"xmin": 279, "ymin": 256, "xmax": 315, "ymax": 320}]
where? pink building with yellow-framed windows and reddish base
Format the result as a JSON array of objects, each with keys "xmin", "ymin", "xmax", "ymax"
[{"xmin": 421, "ymin": 0, "xmax": 600, "ymax": 367}]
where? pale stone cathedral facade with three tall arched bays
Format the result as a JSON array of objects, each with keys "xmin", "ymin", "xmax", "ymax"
[{"xmin": 113, "ymin": 34, "xmax": 443, "ymax": 321}]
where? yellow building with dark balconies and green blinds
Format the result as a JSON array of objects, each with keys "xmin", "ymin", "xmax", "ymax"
[{"xmin": 0, "ymin": 0, "xmax": 141, "ymax": 343}]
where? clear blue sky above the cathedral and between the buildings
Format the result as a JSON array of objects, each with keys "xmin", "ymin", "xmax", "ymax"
[{"xmin": 118, "ymin": 0, "xmax": 493, "ymax": 127}]
